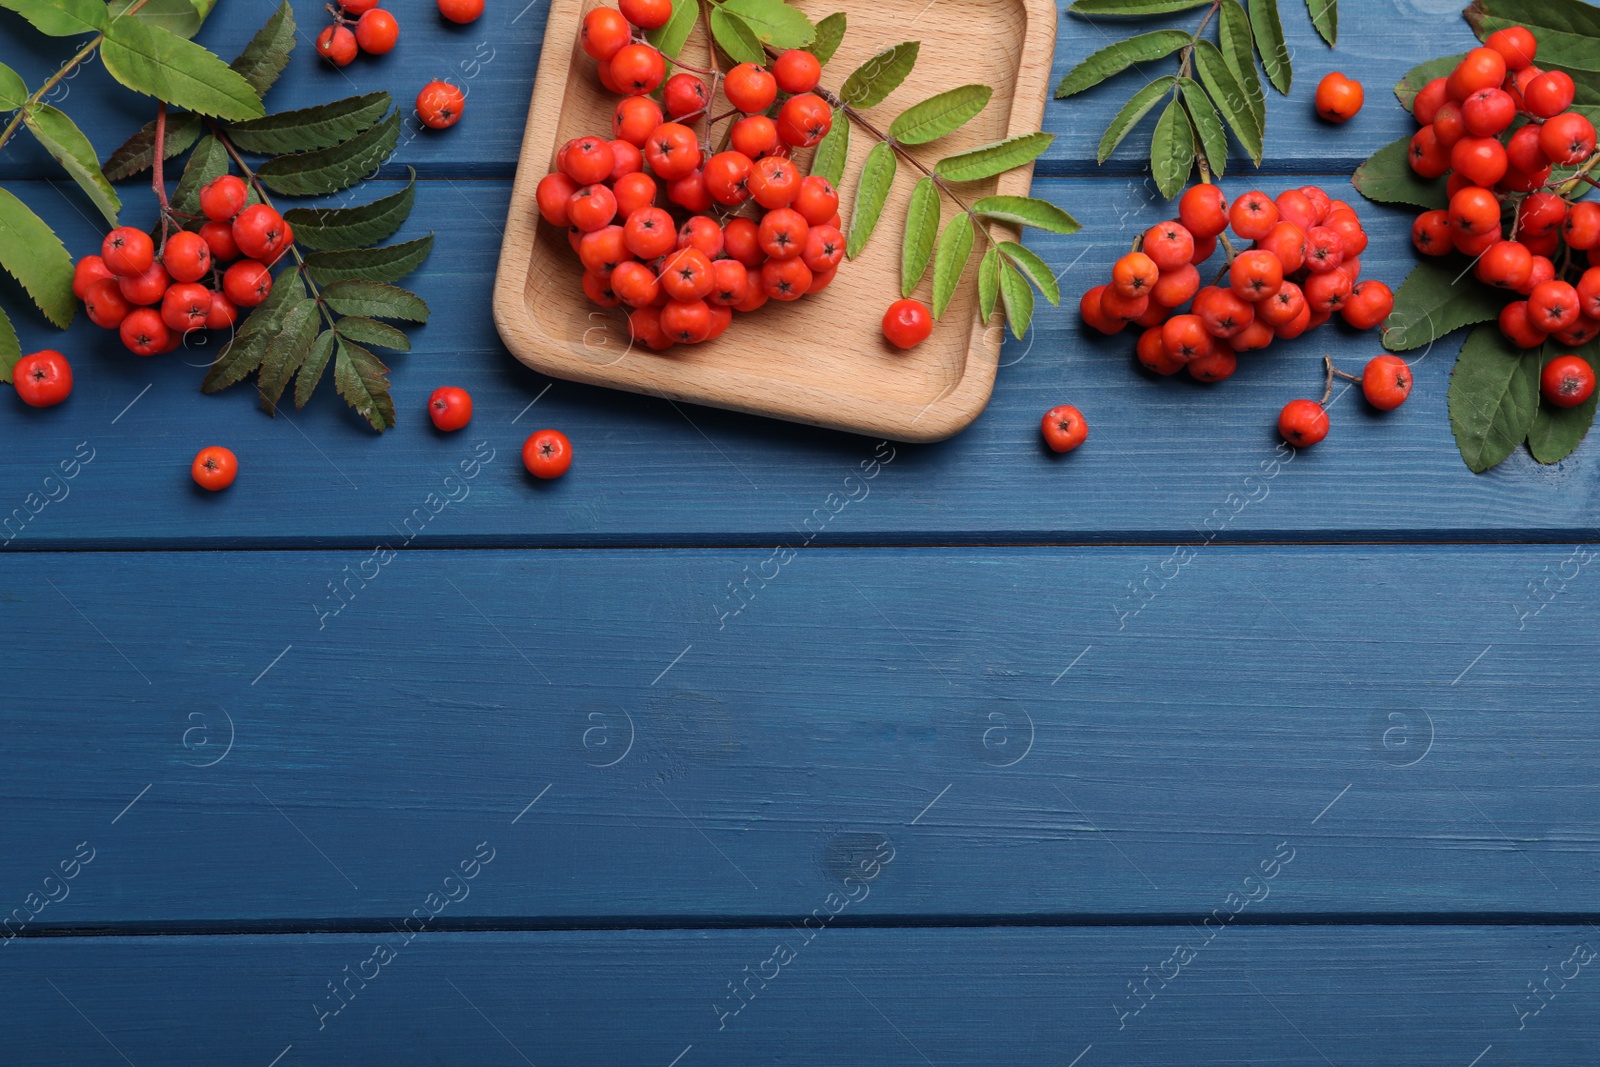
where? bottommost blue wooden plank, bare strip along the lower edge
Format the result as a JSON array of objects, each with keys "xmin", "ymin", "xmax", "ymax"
[{"xmin": 0, "ymin": 927, "xmax": 1600, "ymax": 1067}]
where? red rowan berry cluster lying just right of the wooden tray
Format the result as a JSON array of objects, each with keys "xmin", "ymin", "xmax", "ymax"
[{"xmin": 1078, "ymin": 184, "xmax": 1394, "ymax": 382}]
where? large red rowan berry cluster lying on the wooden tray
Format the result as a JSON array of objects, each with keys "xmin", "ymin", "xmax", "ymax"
[{"xmin": 538, "ymin": 0, "xmax": 845, "ymax": 352}]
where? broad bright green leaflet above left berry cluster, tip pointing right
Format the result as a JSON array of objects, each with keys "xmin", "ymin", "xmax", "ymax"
[{"xmin": 101, "ymin": 19, "xmax": 264, "ymax": 120}]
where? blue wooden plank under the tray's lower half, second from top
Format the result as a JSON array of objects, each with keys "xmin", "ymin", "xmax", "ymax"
[{"xmin": 0, "ymin": 179, "xmax": 1597, "ymax": 550}]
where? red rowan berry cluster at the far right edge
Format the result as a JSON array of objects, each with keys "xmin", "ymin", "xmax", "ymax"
[{"xmin": 1408, "ymin": 26, "xmax": 1600, "ymax": 349}]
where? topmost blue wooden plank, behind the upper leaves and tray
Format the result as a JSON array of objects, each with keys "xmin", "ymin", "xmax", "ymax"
[{"xmin": 0, "ymin": 0, "xmax": 1472, "ymax": 179}]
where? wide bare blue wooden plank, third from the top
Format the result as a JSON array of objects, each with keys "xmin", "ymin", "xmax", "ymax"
[{"xmin": 0, "ymin": 543, "xmax": 1600, "ymax": 934}]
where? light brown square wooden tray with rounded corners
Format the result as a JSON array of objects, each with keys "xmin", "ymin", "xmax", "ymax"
[{"xmin": 494, "ymin": 0, "xmax": 1059, "ymax": 442}]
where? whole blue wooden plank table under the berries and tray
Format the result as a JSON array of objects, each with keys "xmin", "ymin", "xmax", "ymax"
[{"xmin": 0, "ymin": 0, "xmax": 1600, "ymax": 1067}]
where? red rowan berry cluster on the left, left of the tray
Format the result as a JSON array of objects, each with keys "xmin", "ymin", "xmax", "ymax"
[{"xmin": 72, "ymin": 174, "xmax": 294, "ymax": 355}]
